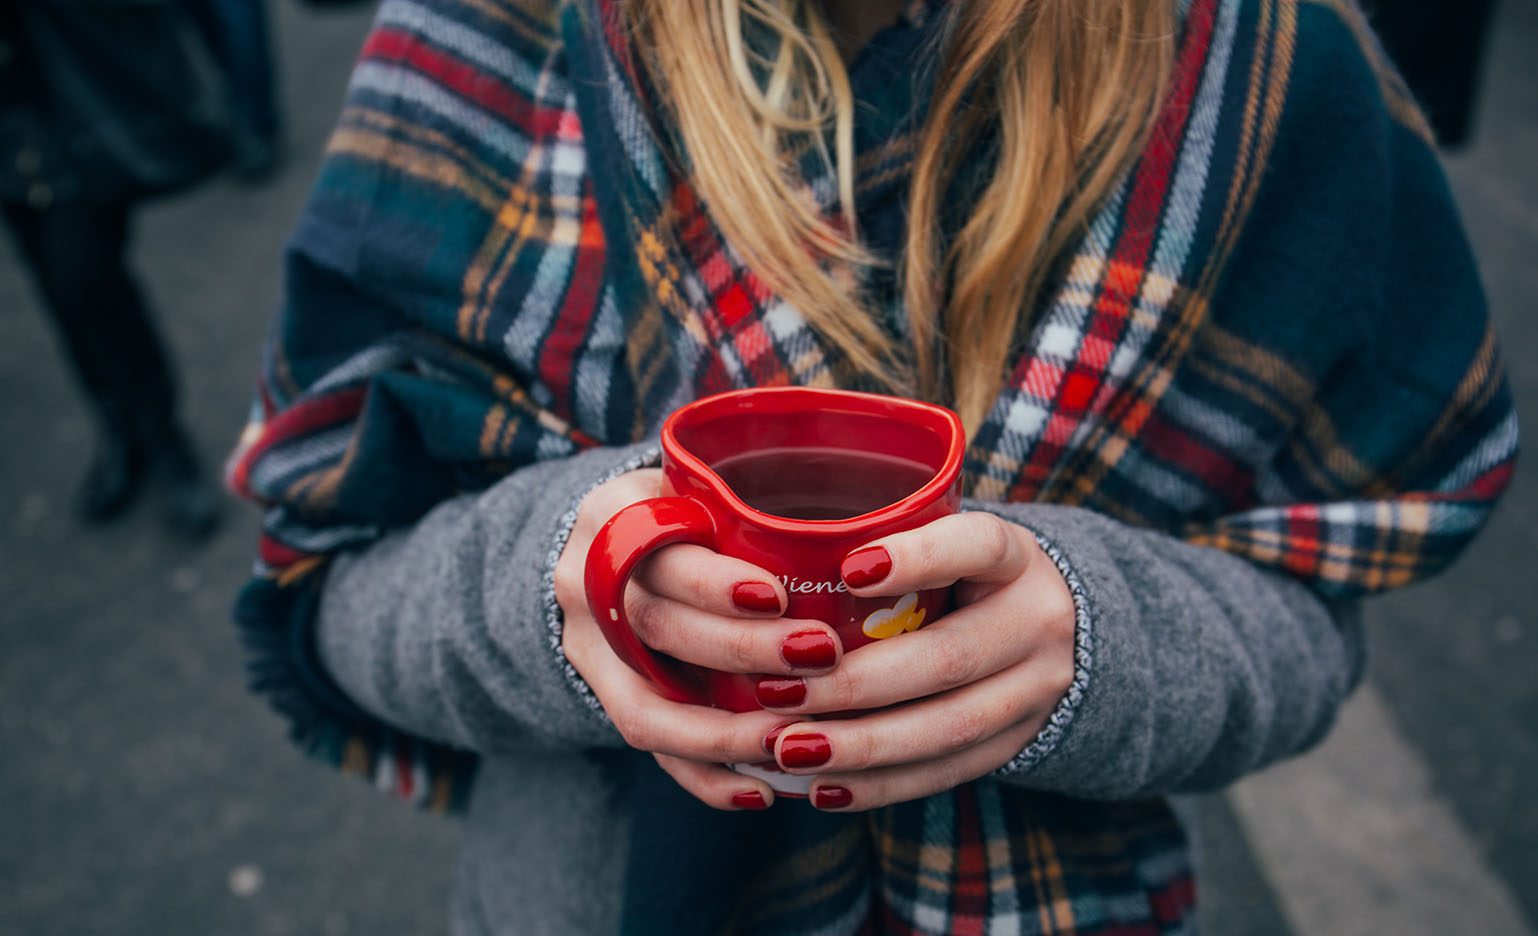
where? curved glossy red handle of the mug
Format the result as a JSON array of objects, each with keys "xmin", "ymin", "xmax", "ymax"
[{"xmin": 583, "ymin": 496, "xmax": 715, "ymax": 705}]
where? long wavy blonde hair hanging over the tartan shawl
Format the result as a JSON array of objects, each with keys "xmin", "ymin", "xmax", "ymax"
[{"xmin": 623, "ymin": 0, "xmax": 1175, "ymax": 432}]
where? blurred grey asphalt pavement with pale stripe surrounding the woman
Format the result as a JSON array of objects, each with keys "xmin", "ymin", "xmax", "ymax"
[{"xmin": 0, "ymin": 0, "xmax": 1538, "ymax": 936}]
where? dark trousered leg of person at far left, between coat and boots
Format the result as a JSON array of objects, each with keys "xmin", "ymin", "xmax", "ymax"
[{"xmin": 5, "ymin": 203, "xmax": 175, "ymax": 435}]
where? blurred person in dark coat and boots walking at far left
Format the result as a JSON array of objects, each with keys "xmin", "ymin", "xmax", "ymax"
[{"xmin": 0, "ymin": 0, "xmax": 228, "ymax": 538}]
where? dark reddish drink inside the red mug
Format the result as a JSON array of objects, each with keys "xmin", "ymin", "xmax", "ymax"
[{"xmin": 711, "ymin": 449, "xmax": 935, "ymax": 519}]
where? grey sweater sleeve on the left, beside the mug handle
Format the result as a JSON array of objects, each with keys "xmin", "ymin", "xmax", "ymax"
[{"xmin": 317, "ymin": 443, "xmax": 657, "ymax": 753}]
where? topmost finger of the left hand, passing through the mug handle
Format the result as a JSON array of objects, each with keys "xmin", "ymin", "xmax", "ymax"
[{"xmin": 635, "ymin": 544, "xmax": 786, "ymax": 618}]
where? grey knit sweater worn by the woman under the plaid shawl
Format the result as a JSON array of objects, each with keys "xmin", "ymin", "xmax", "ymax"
[{"xmin": 320, "ymin": 444, "xmax": 1364, "ymax": 936}]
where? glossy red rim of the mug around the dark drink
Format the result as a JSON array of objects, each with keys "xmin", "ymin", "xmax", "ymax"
[{"xmin": 661, "ymin": 386, "xmax": 966, "ymax": 536}]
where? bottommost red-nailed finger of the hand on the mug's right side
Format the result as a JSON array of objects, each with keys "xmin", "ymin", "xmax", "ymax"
[{"xmin": 811, "ymin": 716, "xmax": 1032, "ymax": 812}]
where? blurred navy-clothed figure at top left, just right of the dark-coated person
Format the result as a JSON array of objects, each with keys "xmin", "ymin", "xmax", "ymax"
[{"xmin": 185, "ymin": 0, "xmax": 281, "ymax": 181}]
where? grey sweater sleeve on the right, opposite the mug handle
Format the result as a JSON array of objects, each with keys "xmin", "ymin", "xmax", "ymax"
[{"xmin": 967, "ymin": 503, "xmax": 1366, "ymax": 799}]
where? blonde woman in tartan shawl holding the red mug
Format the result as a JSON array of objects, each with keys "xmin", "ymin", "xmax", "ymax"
[{"xmin": 232, "ymin": 0, "xmax": 1516, "ymax": 933}]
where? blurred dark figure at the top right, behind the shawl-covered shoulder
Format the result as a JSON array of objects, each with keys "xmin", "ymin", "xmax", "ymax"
[{"xmin": 1367, "ymin": 0, "xmax": 1495, "ymax": 149}]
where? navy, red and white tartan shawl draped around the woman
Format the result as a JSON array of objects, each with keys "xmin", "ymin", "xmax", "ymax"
[{"xmin": 229, "ymin": 0, "xmax": 1516, "ymax": 933}]
